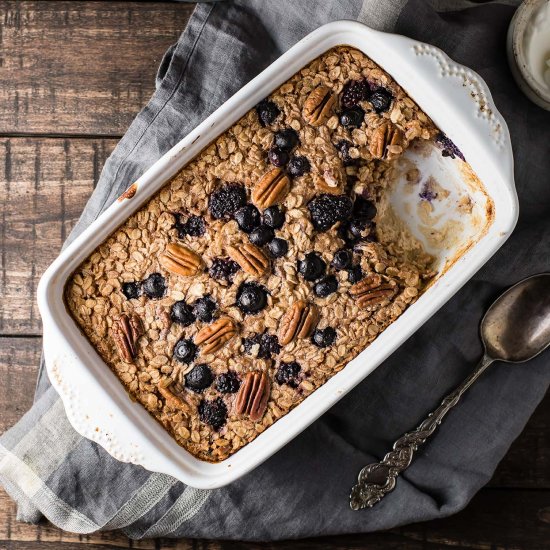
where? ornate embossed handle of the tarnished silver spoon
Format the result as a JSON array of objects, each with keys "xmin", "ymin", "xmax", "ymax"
[{"xmin": 350, "ymin": 354, "xmax": 494, "ymax": 510}]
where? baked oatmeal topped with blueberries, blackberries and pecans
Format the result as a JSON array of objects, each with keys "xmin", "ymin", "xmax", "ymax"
[{"xmin": 65, "ymin": 46, "xmax": 472, "ymax": 462}]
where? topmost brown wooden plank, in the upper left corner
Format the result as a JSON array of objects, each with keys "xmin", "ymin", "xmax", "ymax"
[{"xmin": 0, "ymin": 0, "xmax": 193, "ymax": 136}]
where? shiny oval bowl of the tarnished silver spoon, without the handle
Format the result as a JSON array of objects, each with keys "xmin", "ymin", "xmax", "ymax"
[{"xmin": 481, "ymin": 273, "xmax": 550, "ymax": 363}]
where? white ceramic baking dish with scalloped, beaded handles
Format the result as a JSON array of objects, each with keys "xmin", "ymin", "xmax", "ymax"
[{"xmin": 38, "ymin": 21, "xmax": 518, "ymax": 488}]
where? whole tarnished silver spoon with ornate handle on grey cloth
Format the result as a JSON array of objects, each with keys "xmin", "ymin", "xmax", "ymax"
[{"xmin": 350, "ymin": 273, "xmax": 550, "ymax": 510}]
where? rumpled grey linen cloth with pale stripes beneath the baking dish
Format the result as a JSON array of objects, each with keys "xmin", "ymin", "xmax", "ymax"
[{"xmin": 0, "ymin": 0, "xmax": 550, "ymax": 540}]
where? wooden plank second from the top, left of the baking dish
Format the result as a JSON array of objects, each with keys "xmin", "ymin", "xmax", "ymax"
[{"xmin": 0, "ymin": 138, "xmax": 116, "ymax": 335}]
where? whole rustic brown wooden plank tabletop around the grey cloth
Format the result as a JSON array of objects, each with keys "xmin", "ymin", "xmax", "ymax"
[{"xmin": 0, "ymin": 0, "xmax": 550, "ymax": 550}]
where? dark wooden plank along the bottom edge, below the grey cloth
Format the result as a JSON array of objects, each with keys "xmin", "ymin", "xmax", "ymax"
[{"xmin": 0, "ymin": 489, "xmax": 550, "ymax": 550}]
